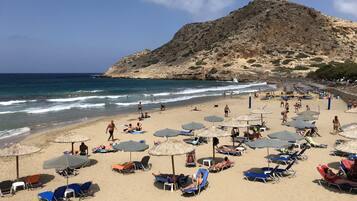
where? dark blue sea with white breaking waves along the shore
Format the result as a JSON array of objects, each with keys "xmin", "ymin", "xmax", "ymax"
[{"xmin": 0, "ymin": 74, "xmax": 275, "ymax": 143}]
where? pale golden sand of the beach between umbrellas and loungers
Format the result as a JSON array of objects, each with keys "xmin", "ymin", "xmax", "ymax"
[{"xmin": 0, "ymin": 93, "xmax": 356, "ymax": 201}]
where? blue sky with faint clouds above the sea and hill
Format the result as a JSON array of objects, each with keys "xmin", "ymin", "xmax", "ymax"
[{"xmin": 0, "ymin": 0, "xmax": 357, "ymax": 73}]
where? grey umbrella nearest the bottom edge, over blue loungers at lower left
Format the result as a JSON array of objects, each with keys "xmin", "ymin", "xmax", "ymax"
[{"xmin": 42, "ymin": 154, "xmax": 89, "ymax": 185}]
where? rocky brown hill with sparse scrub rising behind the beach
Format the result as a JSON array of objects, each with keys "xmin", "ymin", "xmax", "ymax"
[{"xmin": 104, "ymin": 0, "xmax": 357, "ymax": 80}]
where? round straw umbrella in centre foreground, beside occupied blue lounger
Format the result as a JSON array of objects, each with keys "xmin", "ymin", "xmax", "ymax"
[{"xmin": 149, "ymin": 139, "xmax": 195, "ymax": 176}]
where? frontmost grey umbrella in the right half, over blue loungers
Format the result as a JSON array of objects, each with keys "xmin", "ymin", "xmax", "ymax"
[{"xmin": 245, "ymin": 138, "xmax": 291, "ymax": 167}]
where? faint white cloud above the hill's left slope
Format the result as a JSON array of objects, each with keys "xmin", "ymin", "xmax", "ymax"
[{"xmin": 144, "ymin": 0, "xmax": 235, "ymax": 19}]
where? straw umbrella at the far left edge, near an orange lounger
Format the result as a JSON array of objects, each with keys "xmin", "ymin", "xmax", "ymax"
[{"xmin": 0, "ymin": 144, "xmax": 41, "ymax": 179}]
